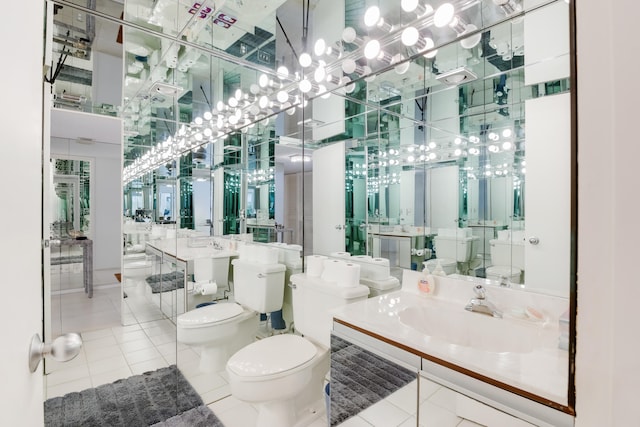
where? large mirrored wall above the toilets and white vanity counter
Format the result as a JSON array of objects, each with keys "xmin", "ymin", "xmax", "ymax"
[{"xmin": 117, "ymin": 0, "xmax": 575, "ymax": 418}]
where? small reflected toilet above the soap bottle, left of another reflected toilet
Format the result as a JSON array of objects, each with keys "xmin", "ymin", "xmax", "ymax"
[{"xmin": 426, "ymin": 228, "xmax": 480, "ymax": 275}]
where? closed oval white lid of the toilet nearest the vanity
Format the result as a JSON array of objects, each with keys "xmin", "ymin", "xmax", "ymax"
[{"xmin": 227, "ymin": 334, "xmax": 318, "ymax": 378}]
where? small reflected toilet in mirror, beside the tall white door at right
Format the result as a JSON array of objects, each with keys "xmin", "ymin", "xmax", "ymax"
[{"xmin": 486, "ymin": 230, "xmax": 524, "ymax": 284}]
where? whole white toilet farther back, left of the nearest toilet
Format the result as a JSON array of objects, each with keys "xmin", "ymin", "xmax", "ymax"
[{"xmin": 176, "ymin": 259, "xmax": 285, "ymax": 373}]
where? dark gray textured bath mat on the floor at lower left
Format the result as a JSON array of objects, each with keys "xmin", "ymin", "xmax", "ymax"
[{"xmin": 44, "ymin": 365, "xmax": 221, "ymax": 427}]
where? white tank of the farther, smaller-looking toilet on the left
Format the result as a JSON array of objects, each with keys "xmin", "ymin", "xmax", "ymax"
[{"xmin": 231, "ymin": 259, "xmax": 286, "ymax": 313}]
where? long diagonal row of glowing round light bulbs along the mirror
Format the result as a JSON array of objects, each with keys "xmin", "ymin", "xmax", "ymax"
[{"xmin": 124, "ymin": 0, "xmax": 521, "ymax": 183}]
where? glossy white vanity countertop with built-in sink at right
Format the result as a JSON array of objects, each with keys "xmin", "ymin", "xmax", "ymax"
[{"xmin": 332, "ymin": 282, "xmax": 568, "ymax": 405}]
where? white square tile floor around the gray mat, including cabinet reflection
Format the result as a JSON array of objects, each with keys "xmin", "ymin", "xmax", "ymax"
[{"xmin": 45, "ymin": 286, "xmax": 478, "ymax": 427}]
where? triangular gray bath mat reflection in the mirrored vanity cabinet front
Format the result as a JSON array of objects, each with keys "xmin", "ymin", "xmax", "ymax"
[{"xmin": 328, "ymin": 335, "xmax": 417, "ymax": 426}]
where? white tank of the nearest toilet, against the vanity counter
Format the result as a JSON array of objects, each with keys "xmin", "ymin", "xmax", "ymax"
[{"xmin": 291, "ymin": 273, "xmax": 369, "ymax": 348}]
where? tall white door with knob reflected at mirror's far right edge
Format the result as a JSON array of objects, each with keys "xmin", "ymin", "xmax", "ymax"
[{"xmin": 524, "ymin": 93, "xmax": 571, "ymax": 295}]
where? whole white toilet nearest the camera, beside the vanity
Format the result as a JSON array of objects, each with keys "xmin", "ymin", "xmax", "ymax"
[{"xmin": 227, "ymin": 273, "xmax": 369, "ymax": 427}]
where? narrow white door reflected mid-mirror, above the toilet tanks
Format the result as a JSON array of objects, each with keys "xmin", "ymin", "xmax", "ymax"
[{"xmin": 313, "ymin": 141, "xmax": 345, "ymax": 255}]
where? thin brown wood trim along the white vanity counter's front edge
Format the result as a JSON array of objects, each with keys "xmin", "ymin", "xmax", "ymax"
[{"xmin": 333, "ymin": 317, "xmax": 575, "ymax": 415}]
